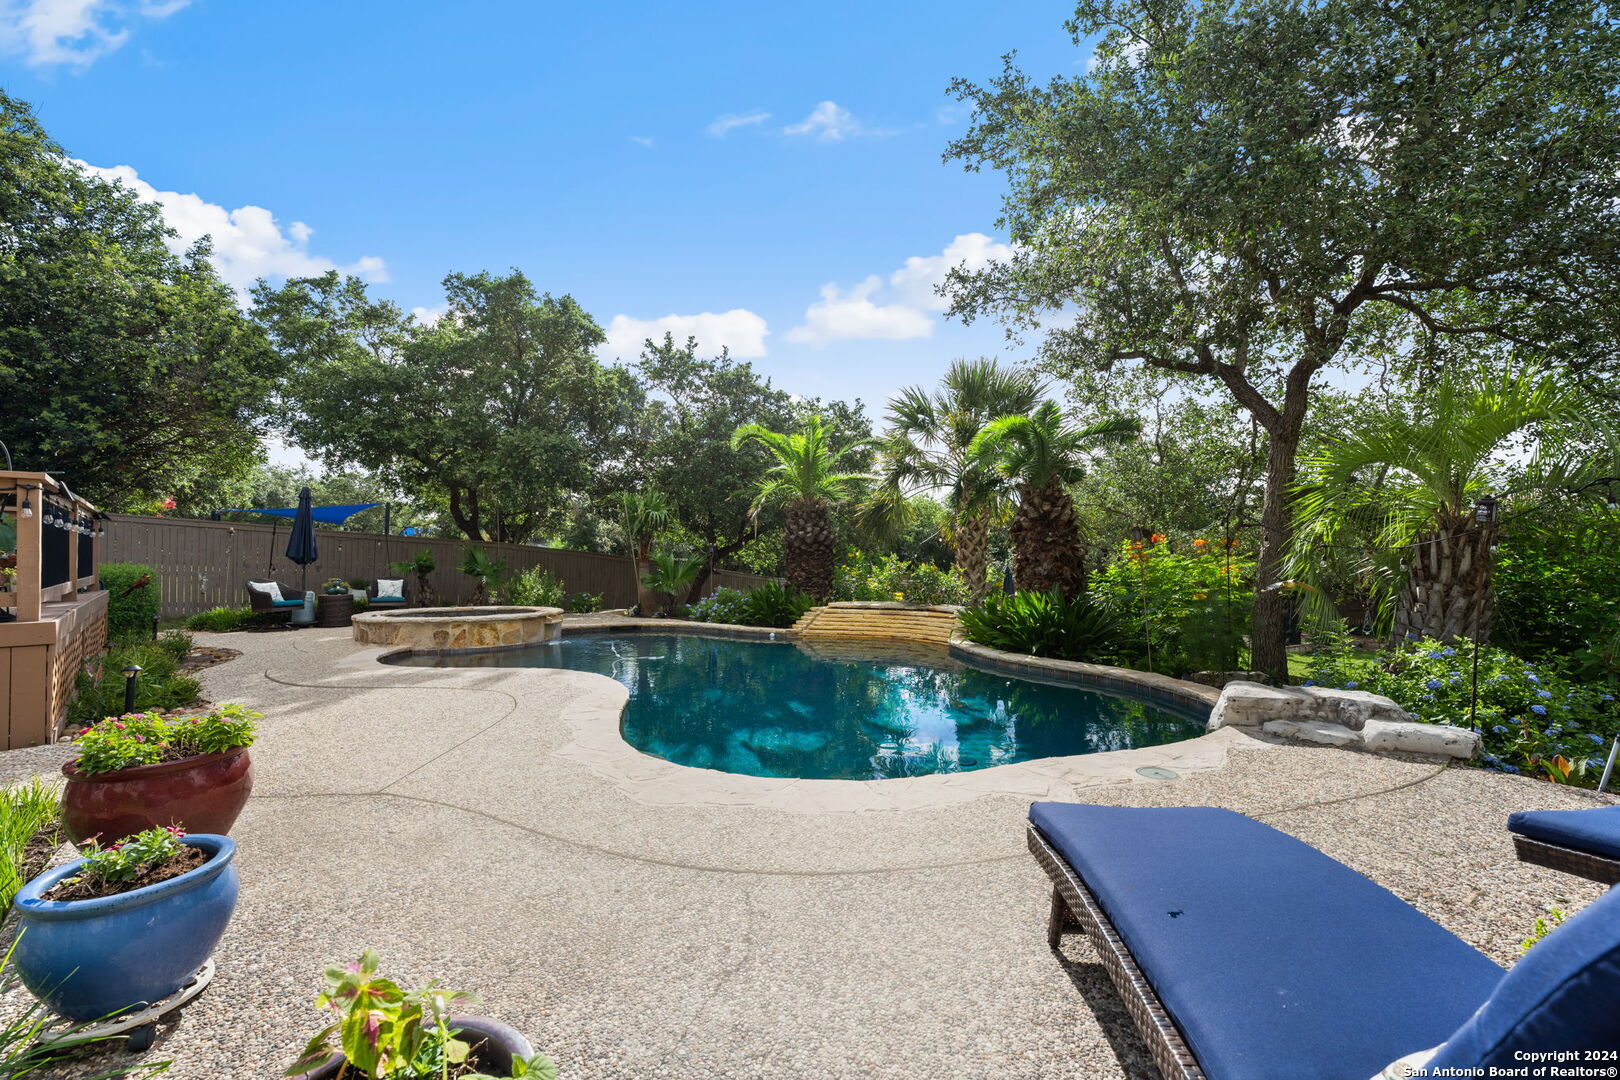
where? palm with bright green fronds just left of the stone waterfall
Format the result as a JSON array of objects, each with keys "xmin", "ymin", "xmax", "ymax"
[{"xmin": 731, "ymin": 416, "xmax": 873, "ymax": 601}]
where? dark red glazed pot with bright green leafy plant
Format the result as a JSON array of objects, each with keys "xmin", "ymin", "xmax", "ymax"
[{"xmin": 62, "ymin": 704, "xmax": 262, "ymax": 844}]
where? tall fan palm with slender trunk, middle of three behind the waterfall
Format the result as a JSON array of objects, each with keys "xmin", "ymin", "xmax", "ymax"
[{"xmin": 868, "ymin": 358, "xmax": 1042, "ymax": 601}]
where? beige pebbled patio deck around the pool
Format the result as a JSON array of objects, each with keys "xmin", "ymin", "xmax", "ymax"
[{"xmin": 0, "ymin": 630, "xmax": 1614, "ymax": 1080}]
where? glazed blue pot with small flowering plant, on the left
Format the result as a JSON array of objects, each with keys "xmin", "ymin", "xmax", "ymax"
[{"xmin": 11, "ymin": 827, "xmax": 237, "ymax": 1020}]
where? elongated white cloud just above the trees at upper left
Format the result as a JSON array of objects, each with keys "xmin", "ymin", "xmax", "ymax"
[{"xmin": 75, "ymin": 162, "xmax": 389, "ymax": 291}]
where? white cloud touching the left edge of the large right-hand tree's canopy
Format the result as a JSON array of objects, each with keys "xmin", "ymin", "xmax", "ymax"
[{"xmin": 786, "ymin": 233, "xmax": 1013, "ymax": 345}]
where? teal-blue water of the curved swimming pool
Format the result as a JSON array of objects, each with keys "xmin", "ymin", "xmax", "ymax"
[{"xmin": 394, "ymin": 633, "xmax": 1204, "ymax": 780}]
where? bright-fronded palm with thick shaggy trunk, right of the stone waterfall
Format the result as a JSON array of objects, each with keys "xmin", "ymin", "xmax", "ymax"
[{"xmin": 967, "ymin": 402, "xmax": 1142, "ymax": 597}]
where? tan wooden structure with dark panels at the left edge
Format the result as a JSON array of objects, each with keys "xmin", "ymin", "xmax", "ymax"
[{"xmin": 0, "ymin": 471, "xmax": 107, "ymax": 750}]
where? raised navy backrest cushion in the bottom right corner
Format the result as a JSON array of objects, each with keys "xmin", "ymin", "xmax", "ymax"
[{"xmin": 1429, "ymin": 880, "xmax": 1620, "ymax": 1075}]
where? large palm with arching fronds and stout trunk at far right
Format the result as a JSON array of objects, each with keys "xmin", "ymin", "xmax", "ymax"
[{"xmin": 1290, "ymin": 369, "xmax": 1591, "ymax": 641}]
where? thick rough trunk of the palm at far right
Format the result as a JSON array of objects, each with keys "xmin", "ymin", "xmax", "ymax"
[{"xmin": 1395, "ymin": 513, "xmax": 1495, "ymax": 644}]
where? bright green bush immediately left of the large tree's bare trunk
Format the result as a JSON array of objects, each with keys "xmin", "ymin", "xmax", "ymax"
[{"xmin": 1092, "ymin": 533, "xmax": 1254, "ymax": 675}]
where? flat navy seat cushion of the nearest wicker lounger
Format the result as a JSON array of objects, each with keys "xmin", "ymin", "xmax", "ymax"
[{"xmin": 1029, "ymin": 803, "xmax": 1502, "ymax": 1080}]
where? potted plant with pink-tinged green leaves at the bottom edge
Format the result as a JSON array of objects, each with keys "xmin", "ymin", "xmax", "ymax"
[{"xmin": 285, "ymin": 949, "xmax": 557, "ymax": 1080}]
